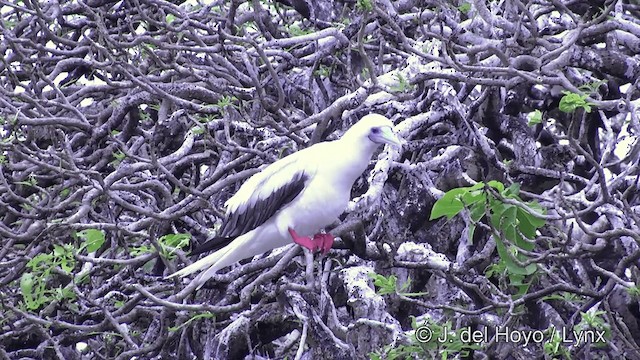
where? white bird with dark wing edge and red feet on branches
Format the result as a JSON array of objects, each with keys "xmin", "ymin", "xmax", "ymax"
[{"xmin": 169, "ymin": 114, "xmax": 401, "ymax": 287}]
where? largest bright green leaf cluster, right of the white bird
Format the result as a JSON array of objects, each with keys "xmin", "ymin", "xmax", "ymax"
[{"xmin": 430, "ymin": 181, "xmax": 545, "ymax": 296}]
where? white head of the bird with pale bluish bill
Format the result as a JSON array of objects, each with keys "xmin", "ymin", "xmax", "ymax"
[{"xmin": 343, "ymin": 114, "xmax": 402, "ymax": 147}]
